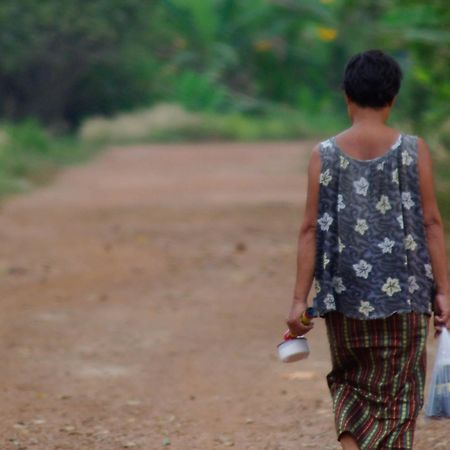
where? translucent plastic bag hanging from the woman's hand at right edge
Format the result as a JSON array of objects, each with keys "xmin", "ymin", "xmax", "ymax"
[{"xmin": 425, "ymin": 327, "xmax": 450, "ymax": 418}]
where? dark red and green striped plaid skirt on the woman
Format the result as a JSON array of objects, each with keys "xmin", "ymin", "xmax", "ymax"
[{"xmin": 325, "ymin": 312, "xmax": 429, "ymax": 450}]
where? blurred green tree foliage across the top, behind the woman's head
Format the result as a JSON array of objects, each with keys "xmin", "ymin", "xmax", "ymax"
[{"xmin": 0, "ymin": 0, "xmax": 450, "ymax": 135}]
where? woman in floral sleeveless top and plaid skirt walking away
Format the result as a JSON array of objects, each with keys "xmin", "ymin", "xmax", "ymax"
[{"xmin": 287, "ymin": 50, "xmax": 450, "ymax": 450}]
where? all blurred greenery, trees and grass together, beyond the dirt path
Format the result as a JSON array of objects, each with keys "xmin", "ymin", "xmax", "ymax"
[{"xmin": 0, "ymin": 0, "xmax": 450, "ymax": 213}]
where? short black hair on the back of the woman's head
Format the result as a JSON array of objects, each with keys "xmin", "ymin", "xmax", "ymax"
[{"xmin": 341, "ymin": 49, "xmax": 403, "ymax": 109}]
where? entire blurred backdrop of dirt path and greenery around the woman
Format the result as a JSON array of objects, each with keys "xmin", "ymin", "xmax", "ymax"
[{"xmin": 0, "ymin": 0, "xmax": 450, "ymax": 450}]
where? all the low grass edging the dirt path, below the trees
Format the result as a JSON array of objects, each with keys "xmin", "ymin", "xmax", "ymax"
[{"xmin": 0, "ymin": 104, "xmax": 450, "ymax": 230}]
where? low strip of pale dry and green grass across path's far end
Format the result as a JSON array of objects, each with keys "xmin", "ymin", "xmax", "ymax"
[{"xmin": 81, "ymin": 104, "xmax": 343, "ymax": 145}]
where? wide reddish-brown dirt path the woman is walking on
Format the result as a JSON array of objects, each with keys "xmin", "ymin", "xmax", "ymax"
[{"xmin": 0, "ymin": 143, "xmax": 450, "ymax": 450}]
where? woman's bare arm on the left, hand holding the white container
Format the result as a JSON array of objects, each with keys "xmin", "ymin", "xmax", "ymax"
[{"xmin": 286, "ymin": 144, "xmax": 321, "ymax": 336}]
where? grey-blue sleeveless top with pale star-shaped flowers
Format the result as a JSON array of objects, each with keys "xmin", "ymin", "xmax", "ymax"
[{"xmin": 313, "ymin": 134, "xmax": 436, "ymax": 319}]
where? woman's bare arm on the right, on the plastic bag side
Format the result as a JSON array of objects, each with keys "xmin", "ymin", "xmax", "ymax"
[{"xmin": 417, "ymin": 138, "xmax": 450, "ymax": 333}]
